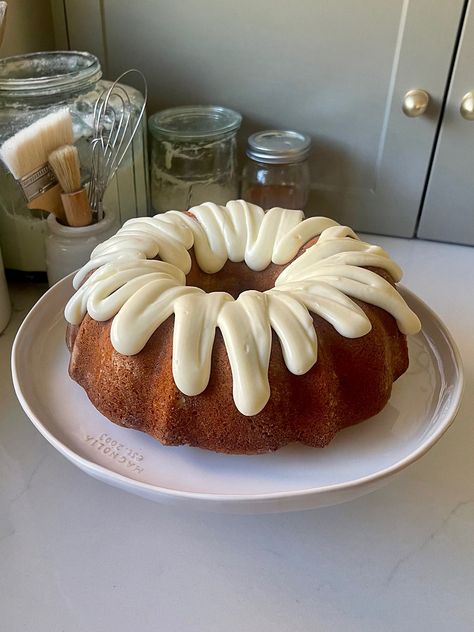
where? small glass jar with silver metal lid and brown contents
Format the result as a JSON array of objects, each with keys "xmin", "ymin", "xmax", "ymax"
[{"xmin": 241, "ymin": 130, "xmax": 311, "ymax": 210}]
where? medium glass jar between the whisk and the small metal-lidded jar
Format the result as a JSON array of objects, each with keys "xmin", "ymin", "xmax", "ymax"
[{"xmin": 149, "ymin": 106, "xmax": 242, "ymax": 212}]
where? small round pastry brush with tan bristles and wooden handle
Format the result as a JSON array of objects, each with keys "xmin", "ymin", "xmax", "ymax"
[{"xmin": 48, "ymin": 145, "xmax": 92, "ymax": 226}]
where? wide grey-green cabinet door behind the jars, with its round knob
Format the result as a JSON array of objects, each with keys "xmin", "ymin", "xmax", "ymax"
[{"xmin": 59, "ymin": 0, "xmax": 463, "ymax": 236}]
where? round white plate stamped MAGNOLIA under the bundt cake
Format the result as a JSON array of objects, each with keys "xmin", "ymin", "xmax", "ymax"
[{"xmin": 12, "ymin": 277, "xmax": 463, "ymax": 513}]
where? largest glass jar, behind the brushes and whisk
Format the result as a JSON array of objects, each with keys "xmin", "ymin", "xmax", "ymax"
[{"xmin": 0, "ymin": 51, "xmax": 148, "ymax": 272}]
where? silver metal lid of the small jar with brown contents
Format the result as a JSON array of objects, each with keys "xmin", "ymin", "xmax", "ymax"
[{"xmin": 246, "ymin": 129, "xmax": 311, "ymax": 164}]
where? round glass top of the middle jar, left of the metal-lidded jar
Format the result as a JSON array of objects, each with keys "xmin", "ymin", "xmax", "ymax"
[{"xmin": 148, "ymin": 105, "xmax": 242, "ymax": 141}]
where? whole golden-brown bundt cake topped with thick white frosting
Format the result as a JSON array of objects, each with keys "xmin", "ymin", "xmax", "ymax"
[{"xmin": 65, "ymin": 200, "xmax": 420, "ymax": 454}]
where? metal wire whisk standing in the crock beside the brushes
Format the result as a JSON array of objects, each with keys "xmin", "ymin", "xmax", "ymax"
[{"xmin": 88, "ymin": 68, "xmax": 148, "ymax": 221}]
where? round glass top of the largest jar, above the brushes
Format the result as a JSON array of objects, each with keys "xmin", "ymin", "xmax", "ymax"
[{"xmin": 0, "ymin": 51, "xmax": 102, "ymax": 98}]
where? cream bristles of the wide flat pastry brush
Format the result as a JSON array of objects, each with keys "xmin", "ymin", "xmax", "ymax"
[{"xmin": 0, "ymin": 108, "xmax": 73, "ymax": 180}]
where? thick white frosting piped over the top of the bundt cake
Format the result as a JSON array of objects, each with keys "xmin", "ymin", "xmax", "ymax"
[{"xmin": 65, "ymin": 200, "xmax": 420, "ymax": 415}]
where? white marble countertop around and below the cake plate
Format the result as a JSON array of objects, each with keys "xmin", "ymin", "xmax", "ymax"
[{"xmin": 0, "ymin": 237, "xmax": 474, "ymax": 632}]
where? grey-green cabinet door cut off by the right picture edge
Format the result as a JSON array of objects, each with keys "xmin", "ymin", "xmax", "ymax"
[{"xmin": 418, "ymin": 1, "xmax": 474, "ymax": 245}]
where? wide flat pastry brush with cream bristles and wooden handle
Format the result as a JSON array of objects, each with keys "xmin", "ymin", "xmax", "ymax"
[{"xmin": 0, "ymin": 108, "xmax": 73, "ymax": 222}]
